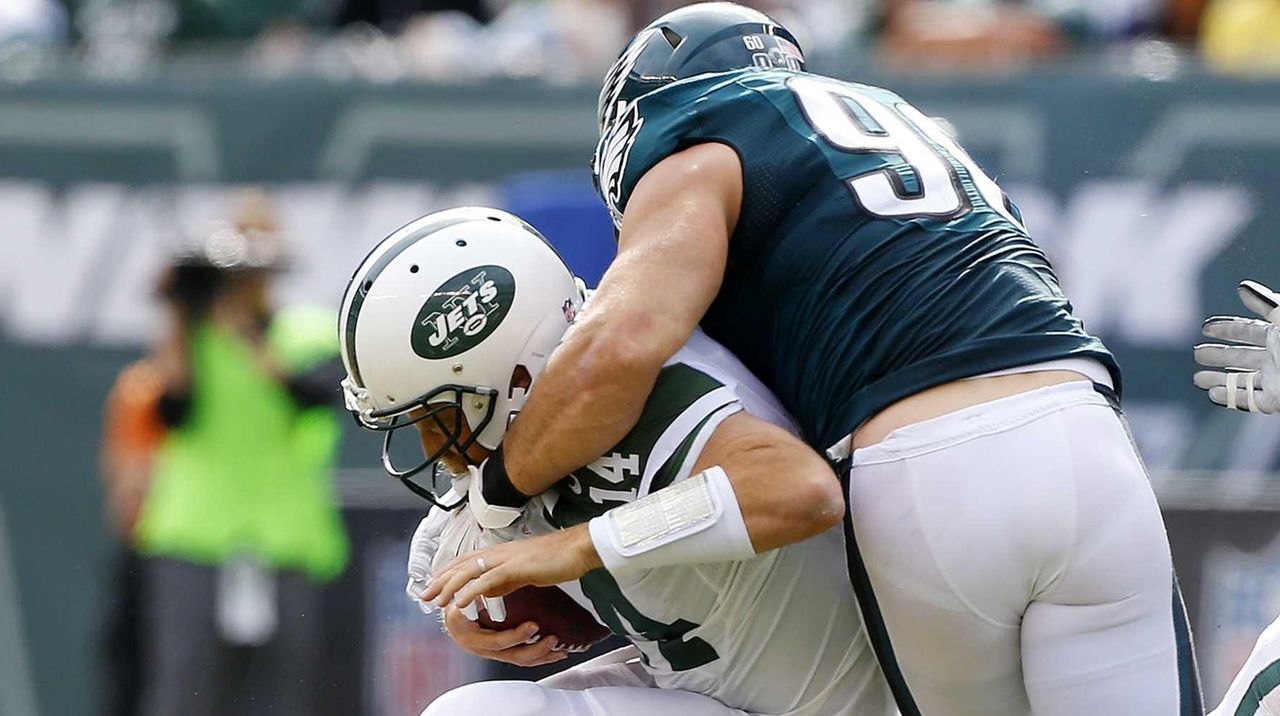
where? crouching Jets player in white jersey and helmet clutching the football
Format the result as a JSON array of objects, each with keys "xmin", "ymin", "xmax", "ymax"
[{"xmin": 340, "ymin": 209, "xmax": 892, "ymax": 716}]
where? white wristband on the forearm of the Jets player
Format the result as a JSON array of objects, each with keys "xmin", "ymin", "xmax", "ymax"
[{"xmin": 588, "ymin": 466, "xmax": 755, "ymax": 575}]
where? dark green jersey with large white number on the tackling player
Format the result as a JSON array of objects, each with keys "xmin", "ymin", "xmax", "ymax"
[{"xmin": 595, "ymin": 69, "xmax": 1119, "ymax": 448}]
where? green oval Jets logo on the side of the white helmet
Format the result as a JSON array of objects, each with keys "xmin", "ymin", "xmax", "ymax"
[{"xmin": 410, "ymin": 265, "xmax": 516, "ymax": 359}]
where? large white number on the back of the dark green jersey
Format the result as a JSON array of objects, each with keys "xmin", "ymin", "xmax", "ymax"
[{"xmin": 787, "ymin": 76, "xmax": 1023, "ymax": 228}]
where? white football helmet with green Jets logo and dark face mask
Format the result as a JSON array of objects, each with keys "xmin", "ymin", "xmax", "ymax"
[{"xmin": 338, "ymin": 206, "xmax": 584, "ymax": 509}]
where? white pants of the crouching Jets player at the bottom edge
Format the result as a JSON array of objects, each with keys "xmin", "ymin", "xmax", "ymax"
[{"xmin": 422, "ymin": 647, "xmax": 751, "ymax": 716}]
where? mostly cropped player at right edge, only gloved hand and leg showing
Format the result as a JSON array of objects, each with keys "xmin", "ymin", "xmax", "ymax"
[{"xmin": 1196, "ymin": 281, "xmax": 1280, "ymax": 716}]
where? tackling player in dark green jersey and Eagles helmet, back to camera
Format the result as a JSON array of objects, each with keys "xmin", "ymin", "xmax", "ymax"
[{"xmin": 458, "ymin": 3, "xmax": 1202, "ymax": 716}]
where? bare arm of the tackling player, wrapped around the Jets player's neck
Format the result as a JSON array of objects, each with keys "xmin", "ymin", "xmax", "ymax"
[{"xmin": 503, "ymin": 143, "xmax": 742, "ymax": 494}]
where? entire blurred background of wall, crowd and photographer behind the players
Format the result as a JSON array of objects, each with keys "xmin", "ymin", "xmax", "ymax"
[{"xmin": 0, "ymin": 0, "xmax": 1280, "ymax": 716}]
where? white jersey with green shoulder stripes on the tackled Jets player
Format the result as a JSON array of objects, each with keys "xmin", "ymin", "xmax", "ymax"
[{"xmin": 545, "ymin": 333, "xmax": 892, "ymax": 716}]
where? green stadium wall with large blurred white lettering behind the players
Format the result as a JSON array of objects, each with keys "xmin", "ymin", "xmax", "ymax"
[{"xmin": 0, "ymin": 70, "xmax": 1280, "ymax": 716}]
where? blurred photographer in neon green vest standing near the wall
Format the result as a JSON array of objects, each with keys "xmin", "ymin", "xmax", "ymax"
[{"xmin": 133, "ymin": 189, "xmax": 348, "ymax": 716}]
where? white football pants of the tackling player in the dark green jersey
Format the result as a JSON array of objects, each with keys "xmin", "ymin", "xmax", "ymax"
[{"xmin": 849, "ymin": 382, "xmax": 1203, "ymax": 716}]
